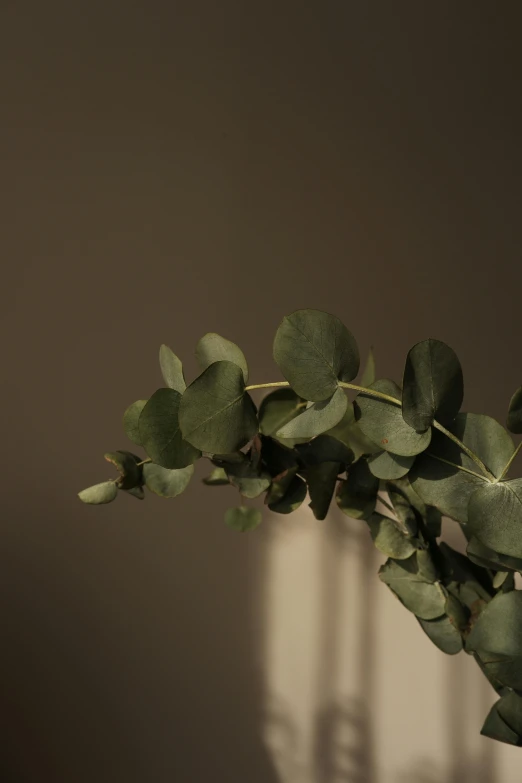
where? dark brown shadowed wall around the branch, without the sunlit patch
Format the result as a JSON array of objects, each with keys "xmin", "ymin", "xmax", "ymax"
[{"xmin": 0, "ymin": 0, "xmax": 522, "ymax": 783}]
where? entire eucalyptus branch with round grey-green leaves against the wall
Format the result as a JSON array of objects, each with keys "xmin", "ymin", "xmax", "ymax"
[{"xmin": 79, "ymin": 310, "xmax": 522, "ymax": 746}]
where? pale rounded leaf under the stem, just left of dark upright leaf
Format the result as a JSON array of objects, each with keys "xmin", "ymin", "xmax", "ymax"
[{"xmin": 354, "ymin": 379, "xmax": 431, "ymax": 457}]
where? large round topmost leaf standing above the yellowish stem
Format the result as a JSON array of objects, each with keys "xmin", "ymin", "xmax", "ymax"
[{"xmin": 274, "ymin": 310, "xmax": 359, "ymax": 402}]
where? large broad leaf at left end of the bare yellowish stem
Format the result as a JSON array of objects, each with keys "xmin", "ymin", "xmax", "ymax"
[{"xmin": 179, "ymin": 361, "xmax": 257, "ymax": 454}]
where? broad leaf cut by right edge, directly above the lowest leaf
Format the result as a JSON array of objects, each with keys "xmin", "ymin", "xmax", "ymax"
[{"xmin": 466, "ymin": 590, "xmax": 522, "ymax": 690}]
